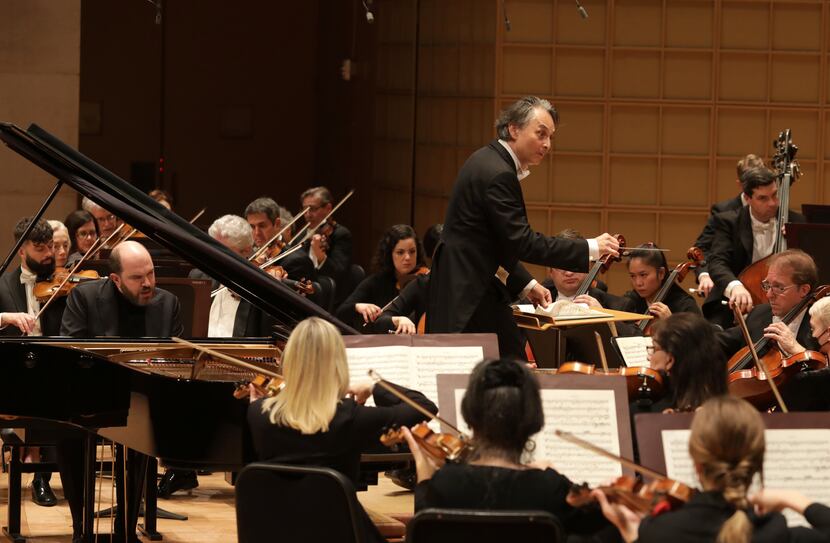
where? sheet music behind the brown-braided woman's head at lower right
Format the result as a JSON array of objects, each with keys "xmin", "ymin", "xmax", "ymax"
[{"xmin": 662, "ymin": 428, "xmax": 830, "ymax": 526}]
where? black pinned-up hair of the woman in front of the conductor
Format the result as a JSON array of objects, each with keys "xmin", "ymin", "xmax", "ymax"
[{"xmin": 461, "ymin": 358, "xmax": 545, "ymax": 464}]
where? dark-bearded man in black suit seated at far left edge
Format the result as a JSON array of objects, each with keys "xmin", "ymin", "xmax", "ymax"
[{"xmin": 0, "ymin": 218, "xmax": 66, "ymax": 507}]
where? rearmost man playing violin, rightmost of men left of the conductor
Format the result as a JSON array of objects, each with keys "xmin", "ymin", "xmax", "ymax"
[{"xmin": 294, "ymin": 187, "xmax": 356, "ymax": 307}]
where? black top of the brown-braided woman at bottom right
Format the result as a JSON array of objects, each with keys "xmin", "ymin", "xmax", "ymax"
[{"xmin": 637, "ymin": 492, "xmax": 830, "ymax": 543}]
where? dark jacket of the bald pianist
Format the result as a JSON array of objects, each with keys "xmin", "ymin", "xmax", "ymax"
[{"xmin": 61, "ymin": 279, "xmax": 184, "ymax": 337}]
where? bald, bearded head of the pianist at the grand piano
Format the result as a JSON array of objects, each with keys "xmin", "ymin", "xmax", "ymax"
[{"xmin": 110, "ymin": 241, "xmax": 156, "ymax": 305}]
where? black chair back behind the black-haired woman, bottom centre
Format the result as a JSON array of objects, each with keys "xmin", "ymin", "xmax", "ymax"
[{"xmin": 406, "ymin": 509, "xmax": 565, "ymax": 543}]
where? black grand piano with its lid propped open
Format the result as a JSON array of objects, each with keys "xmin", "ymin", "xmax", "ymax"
[{"xmin": 0, "ymin": 123, "xmax": 358, "ymax": 541}]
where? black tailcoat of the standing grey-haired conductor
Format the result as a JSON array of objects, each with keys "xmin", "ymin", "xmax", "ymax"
[{"xmin": 427, "ymin": 140, "xmax": 589, "ymax": 332}]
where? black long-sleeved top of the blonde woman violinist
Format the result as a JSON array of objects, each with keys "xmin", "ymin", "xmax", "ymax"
[{"xmin": 248, "ymin": 386, "xmax": 438, "ymax": 485}]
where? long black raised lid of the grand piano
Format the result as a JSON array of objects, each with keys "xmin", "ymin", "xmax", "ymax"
[{"xmin": 0, "ymin": 123, "xmax": 358, "ymax": 334}]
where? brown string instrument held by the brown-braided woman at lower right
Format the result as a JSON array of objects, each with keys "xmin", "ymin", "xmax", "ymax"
[{"xmin": 565, "ymin": 475, "xmax": 696, "ymax": 516}]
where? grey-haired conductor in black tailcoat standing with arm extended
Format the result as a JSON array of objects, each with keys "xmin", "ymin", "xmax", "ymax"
[{"xmin": 426, "ymin": 96, "xmax": 619, "ymax": 359}]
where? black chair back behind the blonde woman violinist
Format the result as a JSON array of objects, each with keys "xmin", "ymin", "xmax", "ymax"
[{"xmin": 236, "ymin": 463, "xmax": 368, "ymax": 543}]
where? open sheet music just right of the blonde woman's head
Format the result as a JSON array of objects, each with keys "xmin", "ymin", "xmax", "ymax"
[{"xmin": 346, "ymin": 345, "xmax": 484, "ymax": 405}]
